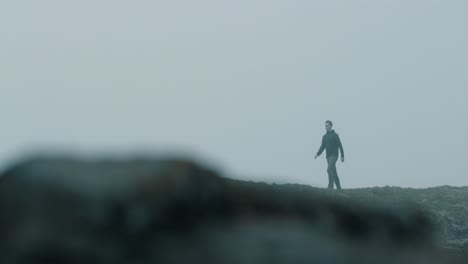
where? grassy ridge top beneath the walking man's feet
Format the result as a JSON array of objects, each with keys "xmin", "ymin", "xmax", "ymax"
[{"xmin": 278, "ymin": 184, "xmax": 468, "ymax": 253}]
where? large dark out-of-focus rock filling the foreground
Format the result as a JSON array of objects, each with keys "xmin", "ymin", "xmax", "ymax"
[{"xmin": 0, "ymin": 158, "xmax": 464, "ymax": 264}]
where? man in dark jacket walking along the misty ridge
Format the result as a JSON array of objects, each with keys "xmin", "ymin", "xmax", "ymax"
[{"xmin": 315, "ymin": 120, "xmax": 344, "ymax": 189}]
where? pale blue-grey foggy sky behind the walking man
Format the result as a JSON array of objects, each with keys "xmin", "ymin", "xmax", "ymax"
[{"xmin": 0, "ymin": 0, "xmax": 468, "ymax": 188}]
